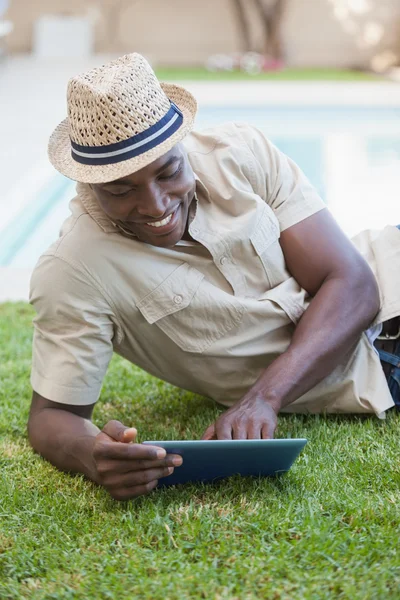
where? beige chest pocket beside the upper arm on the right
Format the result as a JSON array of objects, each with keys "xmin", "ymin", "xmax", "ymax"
[{"xmin": 250, "ymin": 204, "xmax": 290, "ymax": 289}]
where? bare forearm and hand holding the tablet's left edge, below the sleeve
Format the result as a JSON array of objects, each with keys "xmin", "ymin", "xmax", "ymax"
[{"xmin": 28, "ymin": 392, "xmax": 182, "ymax": 500}]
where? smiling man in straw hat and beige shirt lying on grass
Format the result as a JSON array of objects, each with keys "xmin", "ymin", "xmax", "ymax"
[{"xmin": 28, "ymin": 54, "xmax": 400, "ymax": 499}]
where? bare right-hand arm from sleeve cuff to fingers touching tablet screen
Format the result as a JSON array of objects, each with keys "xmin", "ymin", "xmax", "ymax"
[{"xmin": 203, "ymin": 210, "xmax": 379, "ymax": 439}]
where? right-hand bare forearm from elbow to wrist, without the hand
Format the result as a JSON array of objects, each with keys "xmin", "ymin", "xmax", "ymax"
[{"xmin": 245, "ymin": 278, "xmax": 379, "ymax": 411}]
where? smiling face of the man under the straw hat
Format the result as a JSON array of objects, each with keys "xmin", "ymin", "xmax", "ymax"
[{"xmin": 91, "ymin": 144, "xmax": 196, "ymax": 247}]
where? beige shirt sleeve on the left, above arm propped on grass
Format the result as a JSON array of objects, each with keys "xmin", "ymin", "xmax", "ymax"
[{"xmin": 30, "ymin": 255, "xmax": 114, "ymax": 405}]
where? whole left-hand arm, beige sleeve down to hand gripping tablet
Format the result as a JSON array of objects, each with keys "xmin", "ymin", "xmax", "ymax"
[{"xmin": 28, "ymin": 255, "xmax": 182, "ymax": 500}]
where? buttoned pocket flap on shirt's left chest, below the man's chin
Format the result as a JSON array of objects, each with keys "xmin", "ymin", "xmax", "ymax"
[{"xmin": 136, "ymin": 263, "xmax": 204, "ymax": 324}]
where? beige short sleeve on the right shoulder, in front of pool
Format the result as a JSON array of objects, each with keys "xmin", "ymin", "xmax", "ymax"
[{"xmin": 237, "ymin": 124, "xmax": 326, "ymax": 231}]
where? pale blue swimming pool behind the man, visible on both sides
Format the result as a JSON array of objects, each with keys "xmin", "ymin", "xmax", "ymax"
[{"xmin": 0, "ymin": 106, "xmax": 400, "ymax": 269}]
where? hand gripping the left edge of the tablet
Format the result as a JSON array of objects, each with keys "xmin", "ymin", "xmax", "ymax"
[{"xmin": 93, "ymin": 421, "xmax": 182, "ymax": 500}]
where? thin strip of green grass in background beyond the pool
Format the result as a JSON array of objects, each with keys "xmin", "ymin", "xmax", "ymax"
[{"xmin": 156, "ymin": 67, "xmax": 382, "ymax": 81}]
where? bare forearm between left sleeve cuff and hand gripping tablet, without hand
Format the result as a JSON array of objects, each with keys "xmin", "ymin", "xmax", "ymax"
[{"xmin": 28, "ymin": 408, "xmax": 100, "ymax": 481}]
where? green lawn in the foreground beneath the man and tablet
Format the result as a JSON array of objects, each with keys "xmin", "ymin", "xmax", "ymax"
[{"xmin": 0, "ymin": 304, "xmax": 400, "ymax": 600}]
